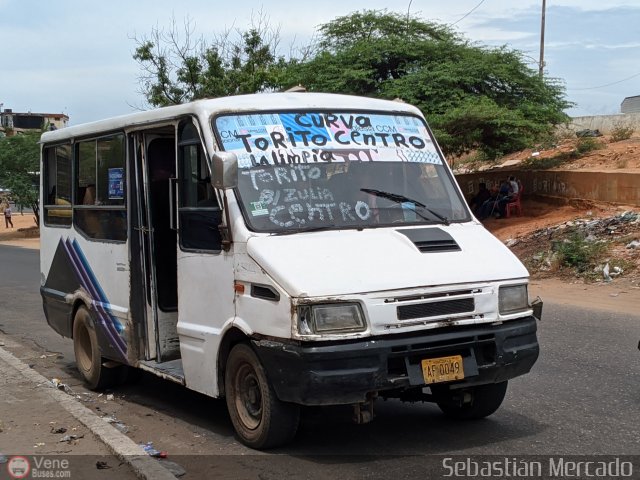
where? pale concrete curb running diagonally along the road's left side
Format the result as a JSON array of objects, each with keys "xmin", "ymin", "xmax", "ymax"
[{"xmin": 0, "ymin": 347, "xmax": 176, "ymax": 480}]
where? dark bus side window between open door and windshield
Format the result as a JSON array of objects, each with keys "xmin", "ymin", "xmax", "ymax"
[{"xmin": 178, "ymin": 120, "xmax": 222, "ymax": 252}]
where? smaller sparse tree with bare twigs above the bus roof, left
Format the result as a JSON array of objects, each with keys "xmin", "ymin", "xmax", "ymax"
[{"xmin": 133, "ymin": 14, "xmax": 283, "ymax": 106}]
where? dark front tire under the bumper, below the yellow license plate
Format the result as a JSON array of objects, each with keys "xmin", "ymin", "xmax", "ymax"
[{"xmin": 432, "ymin": 381, "xmax": 508, "ymax": 420}]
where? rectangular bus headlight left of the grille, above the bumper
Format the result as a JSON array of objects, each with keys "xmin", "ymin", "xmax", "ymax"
[{"xmin": 298, "ymin": 303, "xmax": 366, "ymax": 335}]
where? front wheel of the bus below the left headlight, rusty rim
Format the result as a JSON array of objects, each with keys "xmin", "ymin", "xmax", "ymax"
[{"xmin": 224, "ymin": 343, "xmax": 300, "ymax": 449}]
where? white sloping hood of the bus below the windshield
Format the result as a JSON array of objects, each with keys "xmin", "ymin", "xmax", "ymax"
[{"xmin": 248, "ymin": 222, "xmax": 528, "ymax": 297}]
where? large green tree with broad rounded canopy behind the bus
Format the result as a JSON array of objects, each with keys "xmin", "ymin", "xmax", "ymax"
[{"xmin": 280, "ymin": 10, "xmax": 571, "ymax": 158}]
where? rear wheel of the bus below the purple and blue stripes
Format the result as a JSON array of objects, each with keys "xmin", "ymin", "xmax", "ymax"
[{"xmin": 73, "ymin": 306, "xmax": 125, "ymax": 390}]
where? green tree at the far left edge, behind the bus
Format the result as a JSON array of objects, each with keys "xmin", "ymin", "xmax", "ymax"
[{"xmin": 0, "ymin": 132, "xmax": 41, "ymax": 225}]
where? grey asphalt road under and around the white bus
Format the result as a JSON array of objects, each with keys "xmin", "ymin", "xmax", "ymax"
[{"xmin": 0, "ymin": 246, "xmax": 640, "ymax": 478}]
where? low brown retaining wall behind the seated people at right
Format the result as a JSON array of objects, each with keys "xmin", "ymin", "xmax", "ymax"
[{"xmin": 456, "ymin": 170, "xmax": 640, "ymax": 206}]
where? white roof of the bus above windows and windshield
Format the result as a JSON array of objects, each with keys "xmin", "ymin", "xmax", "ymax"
[{"xmin": 41, "ymin": 92, "xmax": 420, "ymax": 143}]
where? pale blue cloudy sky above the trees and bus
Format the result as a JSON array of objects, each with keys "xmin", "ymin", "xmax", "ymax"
[{"xmin": 0, "ymin": 0, "xmax": 640, "ymax": 125}]
